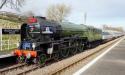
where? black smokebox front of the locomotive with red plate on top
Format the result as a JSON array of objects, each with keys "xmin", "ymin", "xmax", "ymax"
[{"xmin": 21, "ymin": 16, "xmax": 61, "ymax": 42}]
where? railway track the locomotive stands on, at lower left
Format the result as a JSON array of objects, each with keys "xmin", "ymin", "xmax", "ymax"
[{"xmin": 0, "ymin": 58, "xmax": 55, "ymax": 75}]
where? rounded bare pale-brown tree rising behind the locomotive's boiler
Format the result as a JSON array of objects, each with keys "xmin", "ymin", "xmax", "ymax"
[{"xmin": 46, "ymin": 4, "xmax": 70, "ymax": 22}]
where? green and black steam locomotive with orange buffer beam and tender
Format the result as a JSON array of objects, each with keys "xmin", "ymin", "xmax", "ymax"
[{"xmin": 14, "ymin": 16, "xmax": 102, "ymax": 64}]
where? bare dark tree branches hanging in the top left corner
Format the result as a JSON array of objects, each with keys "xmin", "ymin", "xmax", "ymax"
[{"xmin": 0, "ymin": 0, "xmax": 26, "ymax": 10}]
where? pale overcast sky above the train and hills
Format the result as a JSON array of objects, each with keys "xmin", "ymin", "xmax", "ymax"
[{"xmin": 2, "ymin": 0, "xmax": 125, "ymax": 28}]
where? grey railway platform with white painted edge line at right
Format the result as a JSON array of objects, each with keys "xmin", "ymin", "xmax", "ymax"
[{"xmin": 74, "ymin": 39, "xmax": 125, "ymax": 75}]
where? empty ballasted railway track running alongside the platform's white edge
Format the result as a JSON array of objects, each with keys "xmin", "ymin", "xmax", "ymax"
[{"xmin": 26, "ymin": 37, "xmax": 123, "ymax": 75}]
